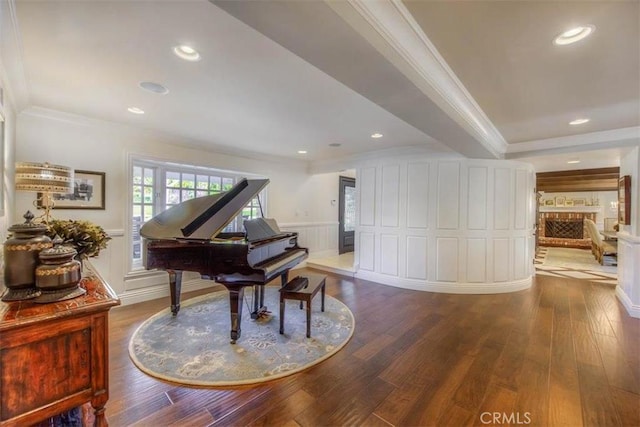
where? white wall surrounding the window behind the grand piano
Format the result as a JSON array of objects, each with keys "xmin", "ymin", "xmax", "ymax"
[{"xmin": 15, "ymin": 109, "xmax": 338, "ymax": 303}]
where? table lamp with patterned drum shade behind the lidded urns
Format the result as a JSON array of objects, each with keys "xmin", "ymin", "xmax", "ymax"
[{"xmin": 16, "ymin": 162, "xmax": 73, "ymax": 224}]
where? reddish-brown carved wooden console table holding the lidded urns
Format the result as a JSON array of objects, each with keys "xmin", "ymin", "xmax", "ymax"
[{"xmin": 0, "ymin": 261, "xmax": 120, "ymax": 427}]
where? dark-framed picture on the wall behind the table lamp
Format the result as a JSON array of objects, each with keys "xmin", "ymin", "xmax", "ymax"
[{"xmin": 38, "ymin": 170, "xmax": 105, "ymax": 209}]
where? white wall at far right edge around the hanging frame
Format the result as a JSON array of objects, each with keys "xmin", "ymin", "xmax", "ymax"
[{"xmin": 616, "ymin": 147, "xmax": 640, "ymax": 318}]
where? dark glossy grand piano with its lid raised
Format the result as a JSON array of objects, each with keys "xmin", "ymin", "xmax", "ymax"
[{"xmin": 140, "ymin": 179, "xmax": 308, "ymax": 343}]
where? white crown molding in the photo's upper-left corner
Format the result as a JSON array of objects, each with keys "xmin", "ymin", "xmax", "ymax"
[{"xmin": 0, "ymin": 0, "xmax": 30, "ymax": 111}]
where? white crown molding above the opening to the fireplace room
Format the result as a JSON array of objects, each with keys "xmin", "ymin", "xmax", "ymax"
[{"xmin": 506, "ymin": 126, "xmax": 640, "ymax": 159}]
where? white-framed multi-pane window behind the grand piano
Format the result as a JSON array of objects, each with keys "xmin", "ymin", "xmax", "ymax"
[{"xmin": 131, "ymin": 160, "xmax": 265, "ymax": 269}]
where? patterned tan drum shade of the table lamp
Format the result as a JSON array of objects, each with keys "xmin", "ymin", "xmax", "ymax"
[{"xmin": 16, "ymin": 162, "xmax": 73, "ymax": 194}]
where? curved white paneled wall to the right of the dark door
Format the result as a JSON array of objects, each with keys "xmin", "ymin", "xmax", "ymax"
[{"xmin": 356, "ymin": 159, "xmax": 535, "ymax": 293}]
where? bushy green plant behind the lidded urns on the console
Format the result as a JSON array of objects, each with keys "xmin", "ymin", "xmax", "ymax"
[{"xmin": 47, "ymin": 219, "xmax": 111, "ymax": 258}]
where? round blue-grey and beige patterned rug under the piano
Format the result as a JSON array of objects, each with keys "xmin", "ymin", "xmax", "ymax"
[{"xmin": 129, "ymin": 286, "xmax": 355, "ymax": 387}]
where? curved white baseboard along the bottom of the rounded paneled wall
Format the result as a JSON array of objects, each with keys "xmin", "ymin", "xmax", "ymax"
[{"xmin": 354, "ymin": 270, "xmax": 532, "ymax": 294}]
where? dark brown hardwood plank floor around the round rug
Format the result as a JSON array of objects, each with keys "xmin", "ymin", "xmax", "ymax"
[{"xmin": 106, "ymin": 275, "xmax": 640, "ymax": 427}]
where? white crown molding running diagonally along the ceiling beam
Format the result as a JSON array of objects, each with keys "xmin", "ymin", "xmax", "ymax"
[{"xmin": 327, "ymin": 0, "xmax": 507, "ymax": 158}]
